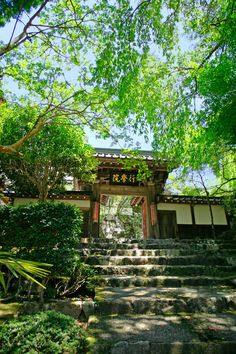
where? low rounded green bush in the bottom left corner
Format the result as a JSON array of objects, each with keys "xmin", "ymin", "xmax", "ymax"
[{"xmin": 0, "ymin": 311, "xmax": 88, "ymax": 354}]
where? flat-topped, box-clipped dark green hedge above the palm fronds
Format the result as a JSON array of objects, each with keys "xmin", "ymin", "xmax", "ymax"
[{"xmin": 0, "ymin": 202, "xmax": 82, "ymax": 249}]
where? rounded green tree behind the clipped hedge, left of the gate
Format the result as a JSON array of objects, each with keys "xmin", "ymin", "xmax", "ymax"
[{"xmin": 0, "ymin": 112, "xmax": 96, "ymax": 201}]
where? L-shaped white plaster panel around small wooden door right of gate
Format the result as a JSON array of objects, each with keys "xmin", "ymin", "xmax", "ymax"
[{"xmin": 157, "ymin": 203, "xmax": 192, "ymax": 225}]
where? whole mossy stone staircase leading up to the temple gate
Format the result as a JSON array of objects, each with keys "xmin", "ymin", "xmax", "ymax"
[{"xmin": 80, "ymin": 239, "xmax": 236, "ymax": 354}]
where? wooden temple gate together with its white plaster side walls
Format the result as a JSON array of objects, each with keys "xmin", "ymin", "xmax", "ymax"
[{"xmin": 8, "ymin": 149, "xmax": 229, "ymax": 238}]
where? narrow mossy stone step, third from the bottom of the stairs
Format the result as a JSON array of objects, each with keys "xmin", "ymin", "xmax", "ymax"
[{"xmin": 97, "ymin": 275, "xmax": 235, "ymax": 287}]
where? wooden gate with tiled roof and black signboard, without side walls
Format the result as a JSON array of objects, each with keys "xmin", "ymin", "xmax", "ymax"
[{"xmin": 86, "ymin": 149, "xmax": 168, "ymax": 238}]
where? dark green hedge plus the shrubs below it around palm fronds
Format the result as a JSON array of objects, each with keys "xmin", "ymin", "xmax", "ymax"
[{"xmin": 0, "ymin": 202, "xmax": 95, "ymax": 298}]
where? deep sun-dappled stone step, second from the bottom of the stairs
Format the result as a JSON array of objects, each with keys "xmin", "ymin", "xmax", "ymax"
[{"xmin": 95, "ymin": 287, "xmax": 236, "ymax": 315}]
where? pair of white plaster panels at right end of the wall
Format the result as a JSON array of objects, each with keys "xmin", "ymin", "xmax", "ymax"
[{"xmin": 194, "ymin": 205, "xmax": 227, "ymax": 225}]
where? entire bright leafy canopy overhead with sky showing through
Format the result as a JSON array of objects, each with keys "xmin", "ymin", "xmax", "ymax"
[{"xmin": 0, "ymin": 0, "xmax": 236, "ymax": 192}]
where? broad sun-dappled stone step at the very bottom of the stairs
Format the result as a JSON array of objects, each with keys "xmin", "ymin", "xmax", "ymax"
[{"xmin": 88, "ymin": 314, "xmax": 236, "ymax": 354}]
